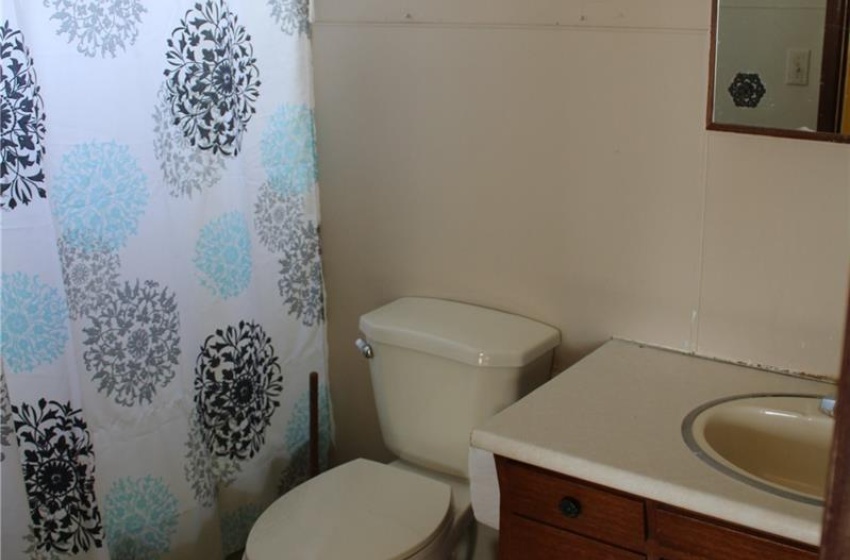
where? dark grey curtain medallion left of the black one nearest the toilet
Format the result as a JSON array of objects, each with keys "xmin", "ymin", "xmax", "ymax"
[{"xmin": 83, "ymin": 280, "xmax": 180, "ymax": 406}]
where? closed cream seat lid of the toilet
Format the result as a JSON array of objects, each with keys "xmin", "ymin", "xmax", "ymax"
[{"xmin": 245, "ymin": 459, "xmax": 451, "ymax": 560}]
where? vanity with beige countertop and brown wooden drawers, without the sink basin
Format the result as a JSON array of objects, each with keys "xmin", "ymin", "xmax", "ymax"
[{"xmin": 471, "ymin": 340, "xmax": 833, "ymax": 560}]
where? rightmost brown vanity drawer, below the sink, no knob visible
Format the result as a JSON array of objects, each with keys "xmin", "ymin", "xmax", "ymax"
[{"xmin": 655, "ymin": 507, "xmax": 818, "ymax": 560}]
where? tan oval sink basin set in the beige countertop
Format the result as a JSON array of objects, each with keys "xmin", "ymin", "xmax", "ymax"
[{"xmin": 682, "ymin": 395, "xmax": 834, "ymax": 505}]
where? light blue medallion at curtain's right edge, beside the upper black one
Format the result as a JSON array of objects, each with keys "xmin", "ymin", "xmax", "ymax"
[{"xmin": 260, "ymin": 105, "xmax": 318, "ymax": 194}]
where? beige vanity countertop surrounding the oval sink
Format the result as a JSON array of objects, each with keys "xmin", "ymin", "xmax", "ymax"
[{"xmin": 471, "ymin": 340, "xmax": 833, "ymax": 545}]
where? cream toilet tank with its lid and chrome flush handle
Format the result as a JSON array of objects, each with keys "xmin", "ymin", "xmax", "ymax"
[{"xmin": 360, "ymin": 297, "xmax": 560, "ymax": 478}]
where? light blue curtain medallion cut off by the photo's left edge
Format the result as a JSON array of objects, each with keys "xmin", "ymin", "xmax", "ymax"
[{"xmin": 0, "ymin": 272, "xmax": 69, "ymax": 373}]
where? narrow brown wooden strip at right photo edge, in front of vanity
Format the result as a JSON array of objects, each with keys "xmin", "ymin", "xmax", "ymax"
[{"xmin": 820, "ymin": 286, "xmax": 850, "ymax": 560}]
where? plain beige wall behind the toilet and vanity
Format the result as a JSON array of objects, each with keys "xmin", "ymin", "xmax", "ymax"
[{"xmin": 314, "ymin": 0, "xmax": 850, "ymax": 460}]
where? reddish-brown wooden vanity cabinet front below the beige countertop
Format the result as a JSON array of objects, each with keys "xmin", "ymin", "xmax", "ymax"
[{"xmin": 496, "ymin": 456, "xmax": 818, "ymax": 560}]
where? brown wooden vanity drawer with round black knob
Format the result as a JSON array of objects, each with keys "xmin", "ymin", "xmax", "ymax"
[{"xmin": 497, "ymin": 458, "xmax": 646, "ymax": 551}]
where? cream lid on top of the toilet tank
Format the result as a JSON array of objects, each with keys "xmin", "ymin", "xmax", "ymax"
[{"xmin": 360, "ymin": 297, "xmax": 561, "ymax": 367}]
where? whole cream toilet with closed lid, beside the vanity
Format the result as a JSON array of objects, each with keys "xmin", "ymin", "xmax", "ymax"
[{"xmin": 244, "ymin": 297, "xmax": 560, "ymax": 560}]
